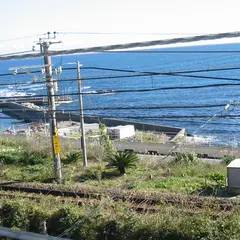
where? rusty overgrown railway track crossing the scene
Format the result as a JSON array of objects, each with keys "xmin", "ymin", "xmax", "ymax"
[{"xmin": 0, "ymin": 183, "xmax": 240, "ymax": 212}]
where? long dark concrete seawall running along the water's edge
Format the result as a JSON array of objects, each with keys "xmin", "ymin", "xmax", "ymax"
[{"xmin": 0, "ymin": 102, "xmax": 185, "ymax": 139}]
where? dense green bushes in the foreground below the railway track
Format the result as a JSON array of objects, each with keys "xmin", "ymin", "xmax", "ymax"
[{"xmin": 0, "ymin": 196, "xmax": 240, "ymax": 240}]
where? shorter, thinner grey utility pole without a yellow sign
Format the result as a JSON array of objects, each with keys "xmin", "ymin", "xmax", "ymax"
[{"xmin": 77, "ymin": 61, "xmax": 87, "ymax": 167}]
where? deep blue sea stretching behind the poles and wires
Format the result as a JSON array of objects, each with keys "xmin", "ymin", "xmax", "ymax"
[{"xmin": 0, "ymin": 43, "xmax": 240, "ymax": 146}]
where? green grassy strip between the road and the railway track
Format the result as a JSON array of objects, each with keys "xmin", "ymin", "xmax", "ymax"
[{"xmin": 0, "ymin": 140, "xmax": 229, "ymax": 194}]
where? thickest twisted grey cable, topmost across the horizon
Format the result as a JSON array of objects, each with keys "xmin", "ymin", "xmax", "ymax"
[{"xmin": 0, "ymin": 32, "xmax": 240, "ymax": 60}]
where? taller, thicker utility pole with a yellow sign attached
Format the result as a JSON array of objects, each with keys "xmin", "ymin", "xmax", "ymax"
[{"xmin": 41, "ymin": 42, "xmax": 62, "ymax": 183}]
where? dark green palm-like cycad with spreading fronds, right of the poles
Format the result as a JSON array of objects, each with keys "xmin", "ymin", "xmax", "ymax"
[{"xmin": 107, "ymin": 152, "xmax": 139, "ymax": 175}]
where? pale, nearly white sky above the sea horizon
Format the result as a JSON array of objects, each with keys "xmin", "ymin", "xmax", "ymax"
[{"xmin": 0, "ymin": 0, "xmax": 240, "ymax": 54}]
